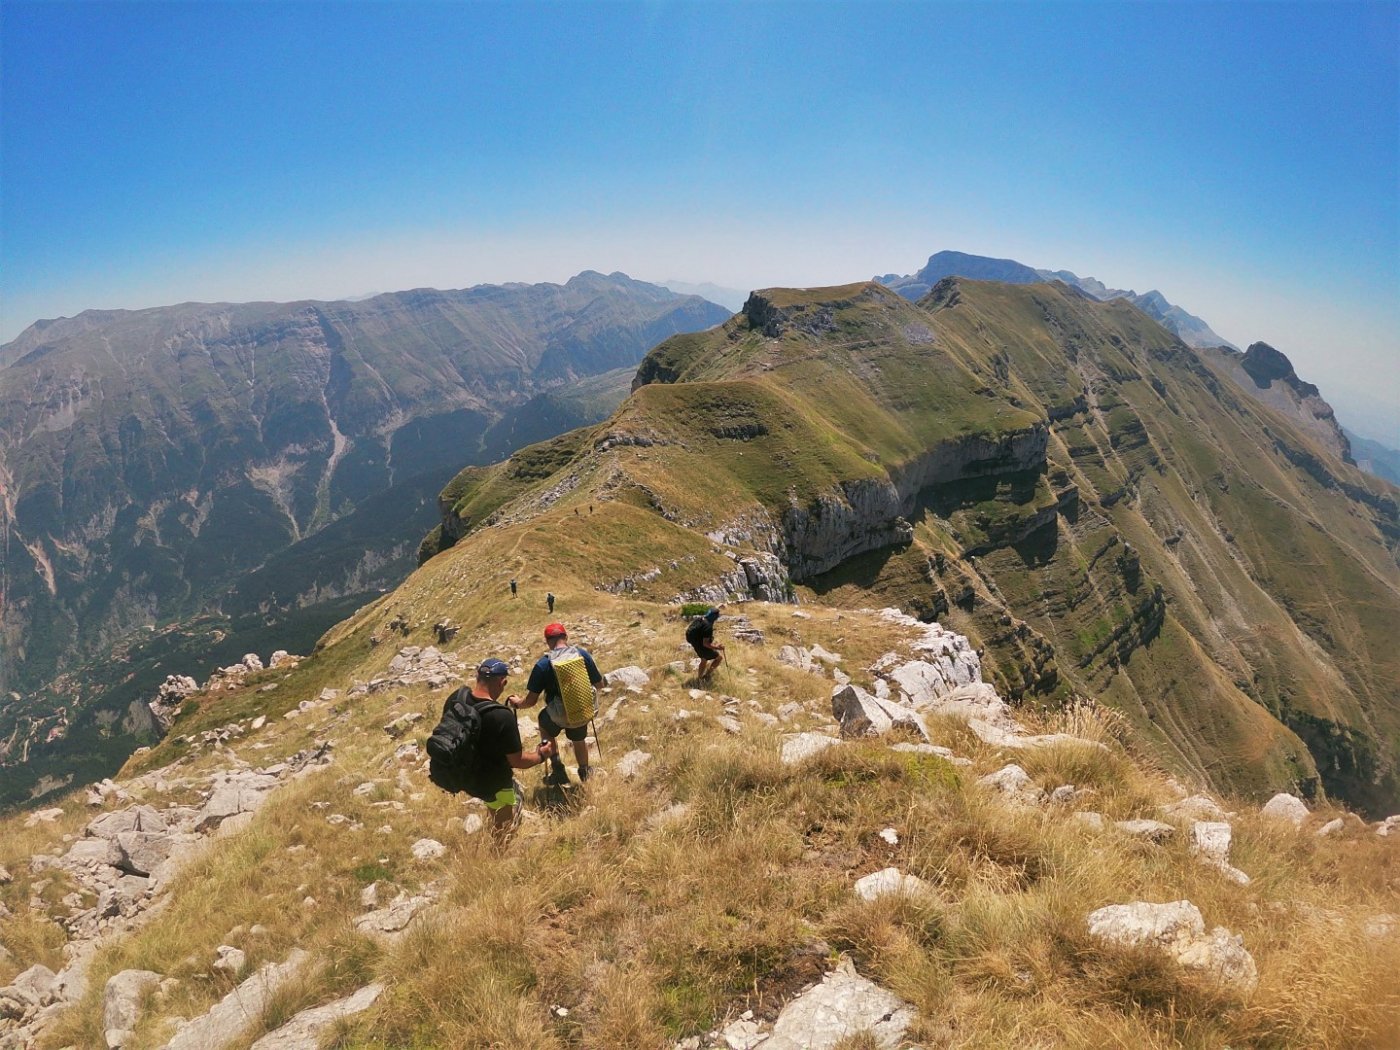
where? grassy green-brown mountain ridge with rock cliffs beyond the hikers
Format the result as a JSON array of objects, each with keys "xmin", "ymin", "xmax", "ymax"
[{"xmin": 421, "ymin": 279, "xmax": 1400, "ymax": 813}]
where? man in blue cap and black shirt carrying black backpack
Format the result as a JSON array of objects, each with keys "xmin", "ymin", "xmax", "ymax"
[{"xmin": 428, "ymin": 659, "xmax": 559, "ymax": 846}]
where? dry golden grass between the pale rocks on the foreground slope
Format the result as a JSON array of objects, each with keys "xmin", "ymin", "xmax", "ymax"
[{"xmin": 10, "ymin": 596, "xmax": 1400, "ymax": 1050}]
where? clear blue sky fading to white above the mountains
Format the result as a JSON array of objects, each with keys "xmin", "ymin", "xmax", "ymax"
[{"xmin": 0, "ymin": 0, "xmax": 1400, "ymax": 444}]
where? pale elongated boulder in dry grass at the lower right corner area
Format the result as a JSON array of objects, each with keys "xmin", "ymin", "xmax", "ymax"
[{"xmin": 1088, "ymin": 900, "xmax": 1259, "ymax": 991}]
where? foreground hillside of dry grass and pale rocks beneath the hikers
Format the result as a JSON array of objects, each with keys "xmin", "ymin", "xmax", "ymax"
[{"xmin": 0, "ymin": 593, "xmax": 1400, "ymax": 1050}]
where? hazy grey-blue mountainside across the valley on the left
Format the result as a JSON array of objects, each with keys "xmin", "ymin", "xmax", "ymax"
[{"xmin": 0, "ymin": 273, "xmax": 728, "ymax": 802}]
